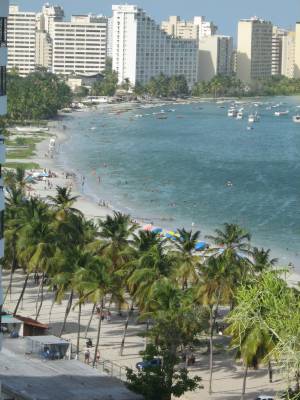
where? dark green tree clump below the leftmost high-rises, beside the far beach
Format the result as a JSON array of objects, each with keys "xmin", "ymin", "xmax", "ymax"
[{"xmin": 7, "ymin": 71, "xmax": 72, "ymax": 121}]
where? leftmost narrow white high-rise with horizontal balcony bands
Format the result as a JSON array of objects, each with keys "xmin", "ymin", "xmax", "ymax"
[{"xmin": 7, "ymin": 5, "xmax": 36, "ymax": 76}]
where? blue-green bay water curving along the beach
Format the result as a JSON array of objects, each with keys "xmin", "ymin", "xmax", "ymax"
[{"xmin": 59, "ymin": 97, "xmax": 300, "ymax": 272}]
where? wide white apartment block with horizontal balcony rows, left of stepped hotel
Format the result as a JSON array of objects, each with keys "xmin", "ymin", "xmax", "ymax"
[{"xmin": 52, "ymin": 15, "xmax": 107, "ymax": 75}]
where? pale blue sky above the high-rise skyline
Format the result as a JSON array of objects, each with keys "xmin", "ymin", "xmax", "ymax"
[{"xmin": 13, "ymin": 0, "xmax": 300, "ymax": 35}]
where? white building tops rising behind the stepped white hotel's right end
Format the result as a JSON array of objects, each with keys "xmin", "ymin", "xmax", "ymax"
[{"xmin": 161, "ymin": 16, "xmax": 217, "ymax": 40}]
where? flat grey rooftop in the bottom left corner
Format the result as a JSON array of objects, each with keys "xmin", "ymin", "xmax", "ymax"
[{"xmin": 0, "ymin": 339, "xmax": 141, "ymax": 400}]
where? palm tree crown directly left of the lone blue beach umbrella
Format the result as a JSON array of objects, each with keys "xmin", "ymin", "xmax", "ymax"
[{"xmin": 174, "ymin": 229, "xmax": 200, "ymax": 289}]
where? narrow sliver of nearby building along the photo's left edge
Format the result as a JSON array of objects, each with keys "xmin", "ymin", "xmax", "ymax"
[{"xmin": 0, "ymin": 0, "xmax": 9, "ymax": 350}]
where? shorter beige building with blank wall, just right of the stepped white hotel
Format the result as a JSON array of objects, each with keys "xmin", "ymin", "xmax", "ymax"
[{"xmin": 198, "ymin": 35, "xmax": 233, "ymax": 81}]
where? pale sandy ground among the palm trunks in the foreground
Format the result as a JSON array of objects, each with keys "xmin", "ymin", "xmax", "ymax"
[{"xmin": 3, "ymin": 271, "xmax": 283, "ymax": 400}]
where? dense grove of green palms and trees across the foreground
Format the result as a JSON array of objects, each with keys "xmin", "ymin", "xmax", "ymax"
[{"xmin": 3, "ymin": 169, "xmax": 300, "ymax": 400}]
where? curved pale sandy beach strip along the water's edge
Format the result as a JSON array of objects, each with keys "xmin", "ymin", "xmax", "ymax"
[{"xmin": 12, "ymin": 99, "xmax": 300, "ymax": 285}]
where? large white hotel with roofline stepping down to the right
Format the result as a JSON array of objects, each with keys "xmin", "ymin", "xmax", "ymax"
[{"xmin": 112, "ymin": 5, "xmax": 198, "ymax": 87}]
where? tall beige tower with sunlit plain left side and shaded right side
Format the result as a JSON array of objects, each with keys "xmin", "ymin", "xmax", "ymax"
[{"xmin": 237, "ymin": 17, "xmax": 273, "ymax": 83}]
